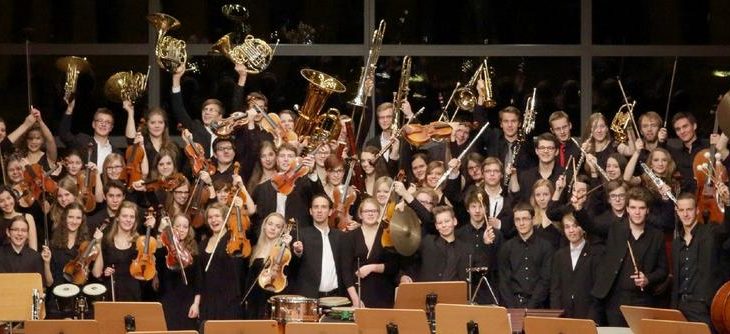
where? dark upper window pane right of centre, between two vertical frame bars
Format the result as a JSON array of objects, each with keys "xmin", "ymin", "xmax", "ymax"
[{"xmin": 375, "ymin": 0, "xmax": 580, "ymax": 44}]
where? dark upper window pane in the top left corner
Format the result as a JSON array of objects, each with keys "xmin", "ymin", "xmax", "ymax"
[{"xmin": 0, "ymin": 0, "xmax": 148, "ymax": 43}]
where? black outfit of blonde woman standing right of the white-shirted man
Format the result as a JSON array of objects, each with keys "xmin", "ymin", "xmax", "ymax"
[{"xmin": 342, "ymin": 225, "xmax": 398, "ymax": 308}]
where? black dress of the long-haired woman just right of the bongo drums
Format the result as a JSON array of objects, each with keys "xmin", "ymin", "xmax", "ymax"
[{"xmin": 103, "ymin": 242, "xmax": 142, "ymax": 302}]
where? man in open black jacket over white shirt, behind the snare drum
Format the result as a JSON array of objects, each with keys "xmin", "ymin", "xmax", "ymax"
[{"xmin": 291, "ymin": 194, "xmax": 346, "ymax": 298}]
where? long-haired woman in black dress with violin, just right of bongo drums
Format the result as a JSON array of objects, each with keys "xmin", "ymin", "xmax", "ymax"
[{"xmin": 102, "ymin": 201, "xmax": 155, "ymax": 301}]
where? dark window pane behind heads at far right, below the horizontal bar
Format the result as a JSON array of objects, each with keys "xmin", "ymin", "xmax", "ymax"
[{"xmin": 593, "ymin": 58, "xmax": 730, "ymax": 136}]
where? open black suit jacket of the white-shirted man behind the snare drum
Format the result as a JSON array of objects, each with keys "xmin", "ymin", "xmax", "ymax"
[{"xmin": 291, "ymin": 225, "xmax": 346, "ymax": 298}]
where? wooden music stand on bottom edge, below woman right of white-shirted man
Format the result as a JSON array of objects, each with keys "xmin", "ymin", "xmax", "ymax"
[{"xmin": 355, "ymin": 308, "xmax": 430, "ymax": 334}]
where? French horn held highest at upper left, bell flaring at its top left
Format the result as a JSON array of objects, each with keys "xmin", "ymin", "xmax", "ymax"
[{"xmin": 147, "ymin": 13, "xmax": 198, "ymax": 73}]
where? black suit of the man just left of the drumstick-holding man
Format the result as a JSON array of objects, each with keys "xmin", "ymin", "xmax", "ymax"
[{"xmin": 550, "ymin": 241, "xmax": 604, "ymax": 322}]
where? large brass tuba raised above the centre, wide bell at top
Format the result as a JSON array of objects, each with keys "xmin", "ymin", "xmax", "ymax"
[{"xmin": 294, "ymin": 69, "xmax": 345, "ymax": 138}]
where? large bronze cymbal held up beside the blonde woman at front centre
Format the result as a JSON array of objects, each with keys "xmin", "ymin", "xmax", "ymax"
[{"xmin": 390, "ymin": 206, "xmax": 421, "ymax": 256}]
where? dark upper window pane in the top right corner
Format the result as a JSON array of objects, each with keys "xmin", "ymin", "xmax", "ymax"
[{"xmin": 593, "ymin": 0, "xmax": 730, "ymax": 44}]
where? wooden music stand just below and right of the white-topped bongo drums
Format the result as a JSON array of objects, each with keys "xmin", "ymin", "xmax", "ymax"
[{"xmin": 94, "ymin": 302, "xmax": 167, "ymax": 334}]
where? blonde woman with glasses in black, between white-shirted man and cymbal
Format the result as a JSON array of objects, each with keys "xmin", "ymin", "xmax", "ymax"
[{"xmin": 342, "ymin": 197, "xmax": 398, "ymax": 308}]
